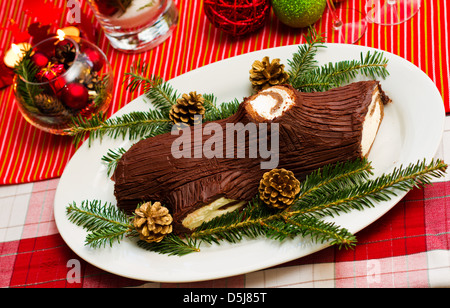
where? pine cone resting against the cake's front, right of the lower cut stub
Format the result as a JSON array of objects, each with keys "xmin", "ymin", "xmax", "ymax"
[{"xmin": 259, "ymin": 169, "xmax": 300, "ymax": 209}]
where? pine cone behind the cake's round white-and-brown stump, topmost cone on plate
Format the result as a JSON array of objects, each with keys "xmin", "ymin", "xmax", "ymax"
[{"xmin": 250, "ymin": 57, "xmax": 289, "ymax": 92}]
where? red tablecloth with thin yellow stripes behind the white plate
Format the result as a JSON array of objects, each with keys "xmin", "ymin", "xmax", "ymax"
[{"xmin": 0, "ymin": 0, "xmax": 450, "ymax": 184}]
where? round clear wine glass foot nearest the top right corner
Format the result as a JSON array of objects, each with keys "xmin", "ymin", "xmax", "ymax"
[{"xmin": 366, "ymin": 0, "xmax": 422, "ymax": 26}]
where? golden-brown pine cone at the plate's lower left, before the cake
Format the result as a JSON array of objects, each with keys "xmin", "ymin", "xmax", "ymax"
[{"xmin": 133, "ymin": 202, "xmax": 173, "ymax": 243}]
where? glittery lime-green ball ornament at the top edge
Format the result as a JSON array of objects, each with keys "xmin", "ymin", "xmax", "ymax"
[{"xmin": 272, "ymin": 0, "xmax": 327, "ymax": 28}]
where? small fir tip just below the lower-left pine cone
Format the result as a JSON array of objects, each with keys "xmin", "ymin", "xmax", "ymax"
[{"xmin": 137, "ymin": 234, "xmax": 200, "ymax": 256}]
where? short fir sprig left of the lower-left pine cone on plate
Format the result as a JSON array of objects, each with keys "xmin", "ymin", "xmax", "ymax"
[{"xmin": 66, "ymin": 200, "xmax": 134, "ymax": 248}]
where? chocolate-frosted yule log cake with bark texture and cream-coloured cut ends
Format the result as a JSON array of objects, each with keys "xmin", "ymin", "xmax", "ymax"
[{"xmin": 113, "ymin": 81, "xmax": 390, "ymax": 234}]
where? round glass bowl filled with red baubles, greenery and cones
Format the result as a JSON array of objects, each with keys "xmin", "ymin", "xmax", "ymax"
[{"xmin": 14, "ymin": 36, "xmax": 114, "ymax": 135}]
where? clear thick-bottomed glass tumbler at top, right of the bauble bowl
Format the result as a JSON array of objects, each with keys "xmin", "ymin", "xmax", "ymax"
[{"xmin": 88, "ymin": 0, "xmax": 178, "ymax": 53}]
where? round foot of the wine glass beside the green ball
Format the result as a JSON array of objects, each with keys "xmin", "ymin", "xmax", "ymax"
[{"xmin": 327, "ymin": 0, "xmax": 367, "ymax": 44}]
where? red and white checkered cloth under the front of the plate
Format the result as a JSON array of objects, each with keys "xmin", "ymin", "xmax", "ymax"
[{"xmin": 0, "ymin": 179, "xmax": 450, "ymax": 288}]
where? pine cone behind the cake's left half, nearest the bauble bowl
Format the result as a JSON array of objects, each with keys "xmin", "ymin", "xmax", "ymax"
[{"xmin": 169, "ymin": 92, "xmax": 205, "ymax": 126}]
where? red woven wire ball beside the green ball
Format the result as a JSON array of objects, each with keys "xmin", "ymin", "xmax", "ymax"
[{"xmin": 203, "ymin": 0, "xmax": 270, "ymax": 37}]
